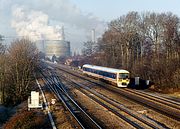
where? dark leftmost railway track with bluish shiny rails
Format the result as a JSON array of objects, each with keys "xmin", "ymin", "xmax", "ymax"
[{"xmin": 39, "ymin": 69, "xmax": 101, "ymax": 129}]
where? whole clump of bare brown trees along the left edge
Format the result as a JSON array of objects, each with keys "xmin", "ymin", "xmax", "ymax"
[{"xmin": 0, "ymin": 36, "xmax": 38, "ymax": 105}]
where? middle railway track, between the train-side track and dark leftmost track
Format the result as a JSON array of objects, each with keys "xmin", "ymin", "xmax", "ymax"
[{"xmin": 60, "ymin": 75, "xmax": 169, "ymax": 129}]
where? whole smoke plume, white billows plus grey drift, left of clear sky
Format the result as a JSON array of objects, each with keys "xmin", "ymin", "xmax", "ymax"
[{"xmin": 0, "ymin": 0, "xmax": 105, "ymax": 49}]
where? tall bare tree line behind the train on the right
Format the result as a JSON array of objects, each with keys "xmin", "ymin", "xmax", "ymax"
[{"xmin": 83, "ymin": 12, "xmax": 180, "ymax": 88}]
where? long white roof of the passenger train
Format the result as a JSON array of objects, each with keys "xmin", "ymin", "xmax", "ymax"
[{"xmin": 83, "ymin": 64, "xmax": 129, "ymax": 73}]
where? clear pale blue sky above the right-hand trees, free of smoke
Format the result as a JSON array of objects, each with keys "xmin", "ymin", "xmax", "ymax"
[{"xmin": 71, "ymin": 0, "xmax": 180, "ymax": 21}]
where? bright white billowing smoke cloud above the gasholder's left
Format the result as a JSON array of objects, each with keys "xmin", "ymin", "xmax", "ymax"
[{"xmin": 11, "ymin": 6, "xmax": 62, "ymax": 41}]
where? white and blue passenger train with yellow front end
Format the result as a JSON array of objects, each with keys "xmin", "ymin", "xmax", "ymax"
[{"xmin": 82, "ymin": 64, "xmax": 130, "ymax": 87}]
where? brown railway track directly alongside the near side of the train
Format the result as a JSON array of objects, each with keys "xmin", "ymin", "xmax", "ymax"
[{"xmin": 50, "ymin": 64, "xmax": 180, "ymax": 121}]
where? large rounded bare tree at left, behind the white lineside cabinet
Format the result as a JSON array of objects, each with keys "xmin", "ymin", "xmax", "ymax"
[{"xmin": 8, "ymin": 39, "xmax": 38, "ymax": 104}]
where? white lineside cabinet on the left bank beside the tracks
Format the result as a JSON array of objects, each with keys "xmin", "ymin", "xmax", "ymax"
[{"xmin": 28, "ymin": 91, "xmax": 42, "ymax": 110}]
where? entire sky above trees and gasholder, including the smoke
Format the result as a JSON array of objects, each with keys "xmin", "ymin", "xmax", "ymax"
[{"xmin": 0, "ymin": 0, "xmax": 180, "ymax": 52}]
